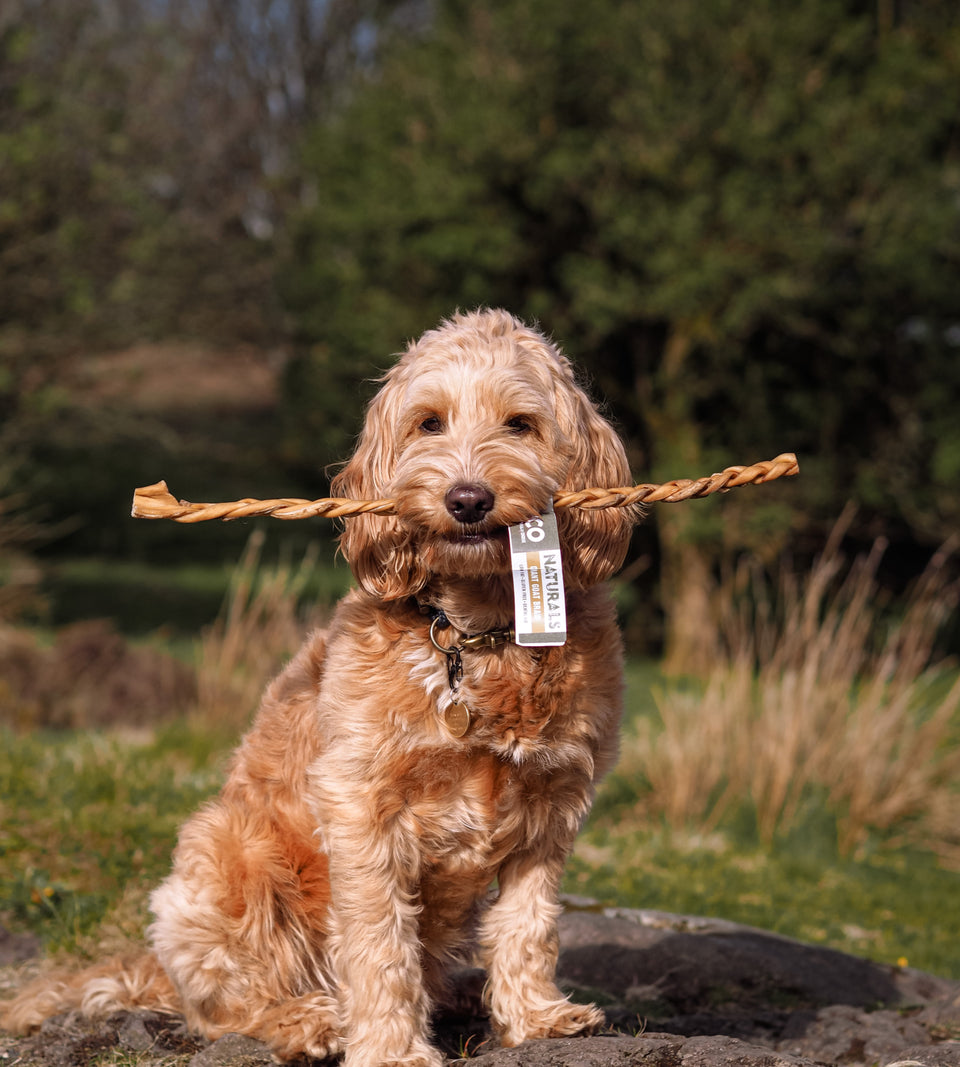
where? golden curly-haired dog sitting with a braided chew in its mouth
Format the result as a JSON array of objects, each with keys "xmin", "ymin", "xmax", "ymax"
[{"xmin": 4, "ymin": 310, "xmax": 637, "ymax": 1067}]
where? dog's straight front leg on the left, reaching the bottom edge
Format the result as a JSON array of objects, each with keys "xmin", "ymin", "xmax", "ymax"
[{"xmin": 327, "ymin": 805, "xmax": 443, "ymax": 1067}]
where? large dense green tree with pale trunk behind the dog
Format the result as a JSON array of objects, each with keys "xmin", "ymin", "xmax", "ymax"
[{"xmin": 284, "ymin": 0, "xmax": 960, "ymax": 669}]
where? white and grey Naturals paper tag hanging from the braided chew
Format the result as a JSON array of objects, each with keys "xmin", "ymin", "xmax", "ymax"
[{"xmin": 510, "ymin": 508, "xmax": 566, "ymax": 644}]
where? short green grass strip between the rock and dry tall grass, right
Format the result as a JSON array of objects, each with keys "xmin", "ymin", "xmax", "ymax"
[{"xmin": 565, "ymin": 827, "xmax": 960, "ymax": 978}]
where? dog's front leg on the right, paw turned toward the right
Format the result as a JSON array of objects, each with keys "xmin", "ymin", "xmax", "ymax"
[{"xmin": 480, "ymin": 849, "xmax": 604, "ymax": 1046}]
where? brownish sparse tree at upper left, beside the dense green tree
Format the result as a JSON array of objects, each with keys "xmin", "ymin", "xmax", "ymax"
[{"xmin": 0, "ymin": 0, "xmax": 409, "ymax": 516}]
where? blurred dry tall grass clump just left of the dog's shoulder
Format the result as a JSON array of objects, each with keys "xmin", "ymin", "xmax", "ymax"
[{"xmin": 196, "ymin": 530, "xmax": 321, "ymax": 730}]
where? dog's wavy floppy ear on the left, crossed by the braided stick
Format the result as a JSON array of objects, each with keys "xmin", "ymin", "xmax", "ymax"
[{"xmin": 331, "ymin": 365, "xmax": 427, "ymax": 600}]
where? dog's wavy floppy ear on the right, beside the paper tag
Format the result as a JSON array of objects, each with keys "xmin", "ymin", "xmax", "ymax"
[{"xmin": 557, "ymin": 372, "xmax": 642, "ymax": 589}]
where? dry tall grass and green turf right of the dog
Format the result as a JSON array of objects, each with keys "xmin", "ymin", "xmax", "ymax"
[{"xmin": 566, "ymin": 537, "xmax": 960, "ymax": 977}]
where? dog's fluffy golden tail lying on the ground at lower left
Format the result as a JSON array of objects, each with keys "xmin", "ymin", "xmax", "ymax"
[{"xmin": 0, "ymin": 952, "xmax": 182, "ymax": 1034}]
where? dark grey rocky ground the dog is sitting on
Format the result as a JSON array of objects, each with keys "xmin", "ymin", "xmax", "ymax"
[{"xmin": 0, "ymin": 907, "xmax": 960, "ymax": 1067}]
